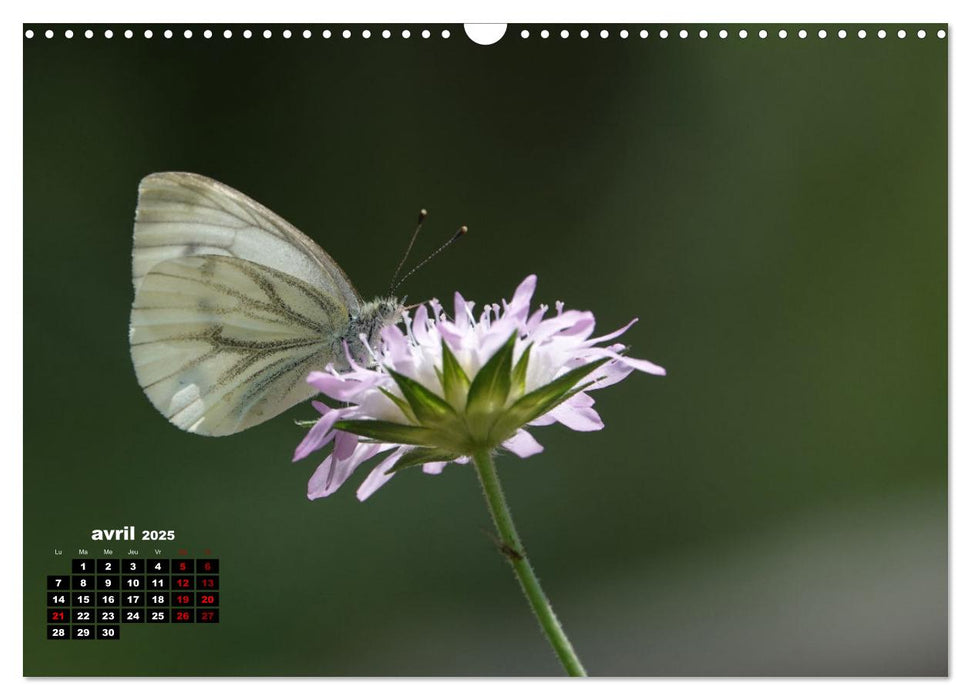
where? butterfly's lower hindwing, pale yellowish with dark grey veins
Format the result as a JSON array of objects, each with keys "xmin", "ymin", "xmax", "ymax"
[{"xmin": 130, "ymin": 255, "xmax": 348, "ymax": 436}]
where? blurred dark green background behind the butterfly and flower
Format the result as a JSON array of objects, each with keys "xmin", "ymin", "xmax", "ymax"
[{"xmin": 24, "ymin": 25, "xmax": 948, "ymax": 676}]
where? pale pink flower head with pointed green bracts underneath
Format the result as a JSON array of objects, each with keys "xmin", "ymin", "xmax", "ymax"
[{"xmin": 294, "ymin": 275, "xmax": 665, "ymax": 501}]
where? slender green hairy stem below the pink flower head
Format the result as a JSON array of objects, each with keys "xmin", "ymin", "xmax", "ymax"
[{"xmin": 472, "ymin": 450, "xmax": 587, "ymax": 676}]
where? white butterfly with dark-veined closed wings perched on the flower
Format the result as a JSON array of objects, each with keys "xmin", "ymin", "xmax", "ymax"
[{"xmin": 129, "ymin": 173, "xmax": 402, "ymax": 435}]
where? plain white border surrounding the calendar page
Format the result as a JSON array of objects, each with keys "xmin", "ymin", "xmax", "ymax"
[{"xmin": 0, "ymin": 0, "xmax": 971, "ymax": 700}]
